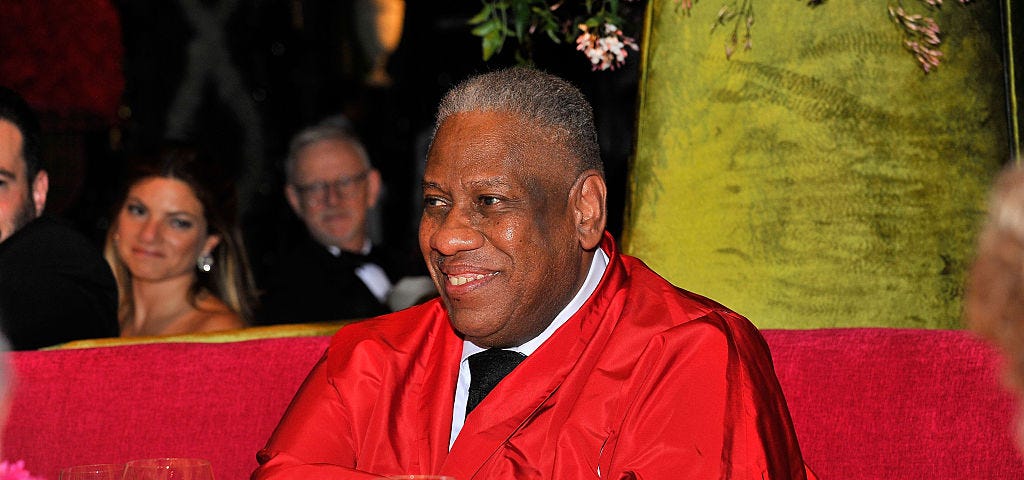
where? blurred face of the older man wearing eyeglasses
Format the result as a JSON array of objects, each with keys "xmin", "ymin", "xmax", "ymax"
[{"xmin": 285, "ymin": 139, "xmax": 381, "ymax": 252}]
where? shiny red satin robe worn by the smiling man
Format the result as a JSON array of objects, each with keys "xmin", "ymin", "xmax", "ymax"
[{"xmin": 253, "ymin": 235, "xmax": 813, "ymax": 480}]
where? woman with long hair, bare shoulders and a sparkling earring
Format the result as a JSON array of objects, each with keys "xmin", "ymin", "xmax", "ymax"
[{"xmin": 103, "ymin": 147, "xmax": 253, "ymax": 337}]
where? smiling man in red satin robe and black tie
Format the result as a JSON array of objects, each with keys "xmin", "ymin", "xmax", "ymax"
[{"xmin": 253, "ymin": 68, "xmax": 813, "ymax": 480}]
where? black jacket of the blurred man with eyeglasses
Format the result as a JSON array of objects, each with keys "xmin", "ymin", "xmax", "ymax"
[{"xmin": 254, "ymin": 235, "xmax": 396, "ymax": 324}]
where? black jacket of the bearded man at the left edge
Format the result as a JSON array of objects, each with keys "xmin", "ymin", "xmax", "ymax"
[{"xmin": 0, "ymin": 217, "xmax": 120, "ymax": 350}]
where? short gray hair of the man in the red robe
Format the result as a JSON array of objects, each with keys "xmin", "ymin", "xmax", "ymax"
[{"xmin": 431, "ymin": 67, "xmax": 604, "ymax": 175}]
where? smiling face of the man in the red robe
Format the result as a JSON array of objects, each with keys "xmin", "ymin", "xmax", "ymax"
[{"xmin": 420, "ymin": 112, "xmax": 604, "ymax": 347}]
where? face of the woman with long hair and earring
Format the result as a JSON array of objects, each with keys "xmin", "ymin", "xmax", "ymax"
[{"xmin": 115, "ymin": 177, "xmax": 220, "ymax": 281}]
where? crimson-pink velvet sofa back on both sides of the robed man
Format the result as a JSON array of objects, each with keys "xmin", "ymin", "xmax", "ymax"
[{"xmin": 3, "ymin": 329, "xmax": 1024, "ymax": 480}]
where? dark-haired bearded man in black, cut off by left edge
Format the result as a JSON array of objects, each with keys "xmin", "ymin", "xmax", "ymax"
[{"xmin": 0, "ymin": 87, "xmax": 118, "ymax": 350}]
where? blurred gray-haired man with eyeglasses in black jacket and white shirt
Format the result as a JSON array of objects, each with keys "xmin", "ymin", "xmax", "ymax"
[{"xmin": 256, "ymin": 119, "xmax": 393, "ymax": 324}]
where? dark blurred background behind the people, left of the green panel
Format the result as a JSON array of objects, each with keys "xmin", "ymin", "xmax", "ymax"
[{"xmin": 0, "ymin": 0, "xmax": 643, "ymax": 288}]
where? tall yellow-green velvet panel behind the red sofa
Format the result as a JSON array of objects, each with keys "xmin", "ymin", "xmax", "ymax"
[{"xmin": 624, "ymin": 0, "xmax": 1010, "ymax": 329}]
